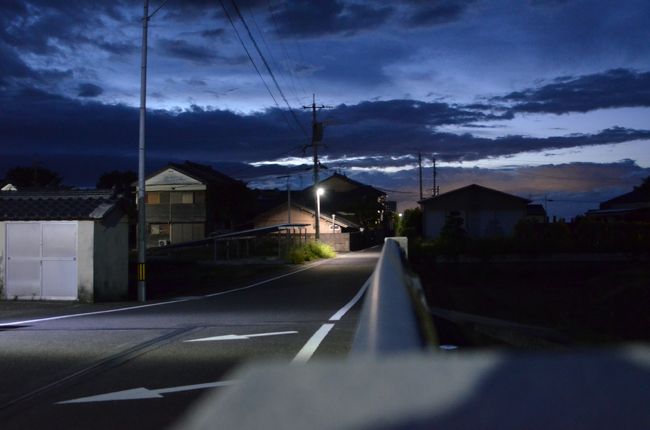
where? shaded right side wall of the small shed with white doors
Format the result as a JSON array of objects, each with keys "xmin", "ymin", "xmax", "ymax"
[{"xmin": 93, "ymin": 217, "xmax": 129, "ymax": 301}]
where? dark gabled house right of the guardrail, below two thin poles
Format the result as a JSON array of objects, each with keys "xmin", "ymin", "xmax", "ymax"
[{"xmin": 419, "ymin": 184, "xmax": 530, "ymax": 239}]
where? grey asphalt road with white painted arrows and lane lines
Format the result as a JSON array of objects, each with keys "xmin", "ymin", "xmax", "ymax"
[{"xmin": 0, "ymin": 248, "xmax": 379, "ymax": 430}]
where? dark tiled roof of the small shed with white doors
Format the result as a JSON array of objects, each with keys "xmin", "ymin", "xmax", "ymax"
[{"xmin": 0, "ymin": 190, "xmax": 121, "ymax": 221}]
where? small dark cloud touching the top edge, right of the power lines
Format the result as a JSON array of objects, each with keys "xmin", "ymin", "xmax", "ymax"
[{"xmin": 273, "ymin": 0, "xmax": 394, "ymax": 37}]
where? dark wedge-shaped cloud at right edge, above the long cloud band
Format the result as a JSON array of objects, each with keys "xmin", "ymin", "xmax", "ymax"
[{"xmin": 493, "ymin": 69, "xmax": 650, "ymax": 114}]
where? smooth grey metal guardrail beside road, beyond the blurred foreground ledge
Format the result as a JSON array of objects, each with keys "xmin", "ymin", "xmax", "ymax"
[{"xmin": 352, "ymin": 238, "xmax": 437, "ymax": 355}]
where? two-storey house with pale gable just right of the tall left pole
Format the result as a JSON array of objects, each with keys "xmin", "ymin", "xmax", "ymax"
[{"xmin": 139, "ymin": 161, "xmax": 253, "ymax": 247}]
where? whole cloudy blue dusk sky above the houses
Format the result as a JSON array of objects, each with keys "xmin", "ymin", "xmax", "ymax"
[{"xmin": 0, "ymin": 0, "xmax": 650, "ymax": 217}]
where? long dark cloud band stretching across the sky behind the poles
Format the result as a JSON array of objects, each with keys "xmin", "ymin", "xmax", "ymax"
[{"xmin": 0, "ymin": 87, "xmax": 650, "ymax": 177}]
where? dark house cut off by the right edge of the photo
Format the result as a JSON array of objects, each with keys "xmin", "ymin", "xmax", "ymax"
[{"xmin": 585, "ymin": 185, "xmax": 650, "ymax": 222}]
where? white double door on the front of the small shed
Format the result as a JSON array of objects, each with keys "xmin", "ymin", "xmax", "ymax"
[{"xmin": 6, "ymin": 221, "xmax": 77, "ymax": 300}]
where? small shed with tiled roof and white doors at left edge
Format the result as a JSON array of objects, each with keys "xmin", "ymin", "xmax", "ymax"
[{"xmin": 0, "ymin": 190, "xmax": 129, "ymax": 302}]
